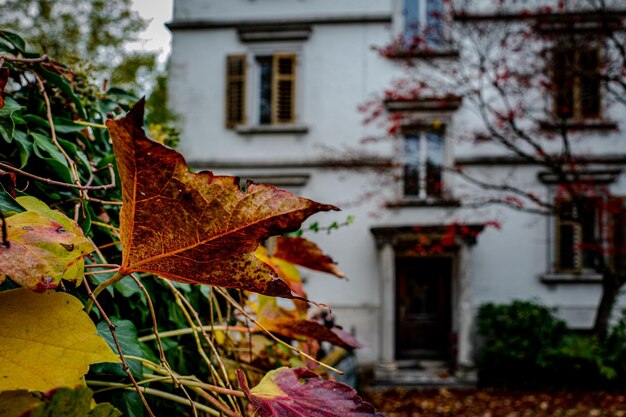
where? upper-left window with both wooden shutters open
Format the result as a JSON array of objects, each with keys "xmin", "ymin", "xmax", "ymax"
[{"xmin": 226, "ymin": 53, "xmax": 296, "ymax": 128}]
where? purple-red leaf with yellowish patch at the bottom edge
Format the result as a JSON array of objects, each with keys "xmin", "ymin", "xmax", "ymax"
[{"xmin": 237, "ymin": 368, "xmax": 383, "ymax": 417}]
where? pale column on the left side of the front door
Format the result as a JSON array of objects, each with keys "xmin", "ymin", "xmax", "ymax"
[{"xmin": 378, "ymin": 241, "xmax": 397, "ymax": 371}]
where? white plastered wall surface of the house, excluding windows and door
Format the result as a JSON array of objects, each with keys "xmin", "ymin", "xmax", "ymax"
[{"xmin": 170, "ymin": 0, "xmax": 626, "ymax": 363}]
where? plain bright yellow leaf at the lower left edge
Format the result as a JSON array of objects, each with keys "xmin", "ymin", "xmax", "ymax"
[{"xmin": 0, "ymin": 289, "xmax": 119, "ymax": 391}]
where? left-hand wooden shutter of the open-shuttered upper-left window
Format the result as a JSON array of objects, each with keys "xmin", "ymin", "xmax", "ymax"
[{"xmin": 226, "ymin": 55, "xmax": 246, "ymax": 128}]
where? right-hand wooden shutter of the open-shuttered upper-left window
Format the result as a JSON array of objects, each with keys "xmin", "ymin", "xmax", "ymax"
[{"xmin": 272, "ymin": 54, "xmax": 296, "ymax": 124}]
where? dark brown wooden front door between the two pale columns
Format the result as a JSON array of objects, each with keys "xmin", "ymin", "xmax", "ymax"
[{"xmin": 395, "ymin": 257, "xmax": 452, "ymax": 359}]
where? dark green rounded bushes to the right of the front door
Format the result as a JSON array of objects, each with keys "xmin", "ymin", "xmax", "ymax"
[{"xmin": 477, "ymin": 301, "xmax": 626, "ymax": 389}]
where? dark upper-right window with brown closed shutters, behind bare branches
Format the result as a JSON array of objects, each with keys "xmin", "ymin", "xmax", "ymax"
[{"xmin": 552, "ymin": 48, "xmax": 600, "ymax": 119}]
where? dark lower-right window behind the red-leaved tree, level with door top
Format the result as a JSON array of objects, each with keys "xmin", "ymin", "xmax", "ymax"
[{"xmin": 556, "ymin": 198, "xmax": 604, "ymax": 273}]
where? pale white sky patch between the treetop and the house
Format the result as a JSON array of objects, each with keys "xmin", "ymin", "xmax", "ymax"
[{"xmin": 127, "ymin": 0, "xmax": 173, "ymax": 64}]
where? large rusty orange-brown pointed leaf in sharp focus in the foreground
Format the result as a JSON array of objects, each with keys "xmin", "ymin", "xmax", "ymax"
[{"xmin": 107, "ymin": 100, "xmax": 338, "ymax": 298}]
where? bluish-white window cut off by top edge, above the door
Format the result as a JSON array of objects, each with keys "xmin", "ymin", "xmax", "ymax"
[{"xmin": 403, "ymin": 0, "xmax": 443, "ymax": 48}]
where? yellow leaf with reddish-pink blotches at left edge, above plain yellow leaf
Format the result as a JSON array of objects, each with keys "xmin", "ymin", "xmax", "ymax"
[{"xmin": 0, "ymin": 197, "xmax": 93, "ymax": 292}]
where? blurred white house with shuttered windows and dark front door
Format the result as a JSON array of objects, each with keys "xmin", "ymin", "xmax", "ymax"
[{"xmin": 169, "ymin": 0, "xmax": 626, "ymax": 379}]
